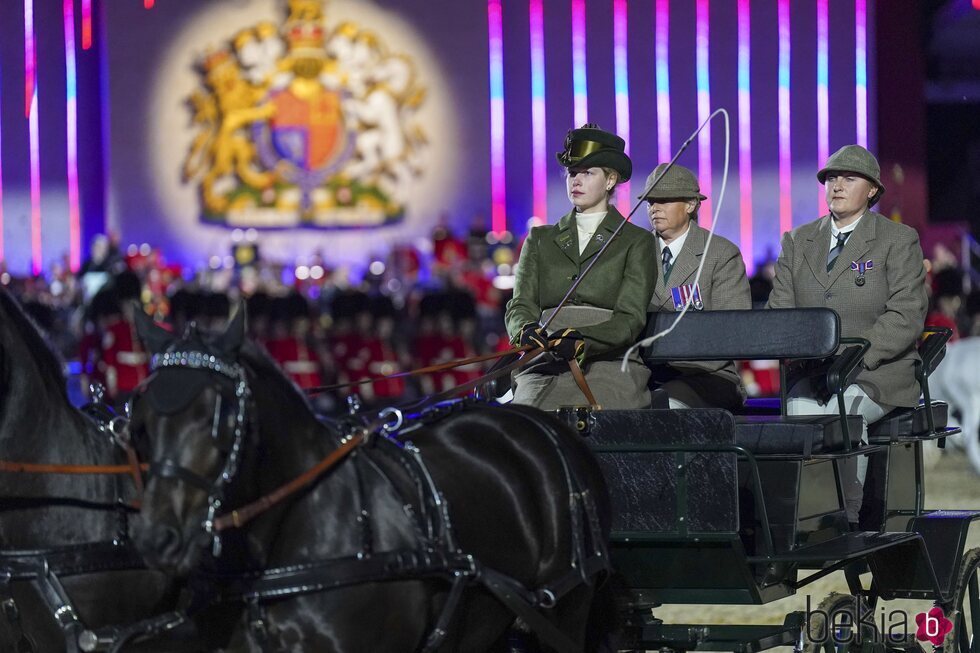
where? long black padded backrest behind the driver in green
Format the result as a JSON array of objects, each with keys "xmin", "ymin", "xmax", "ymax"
[{"xmin": 642, "ymin": 308, "xmax": 840, "ymax": 363}]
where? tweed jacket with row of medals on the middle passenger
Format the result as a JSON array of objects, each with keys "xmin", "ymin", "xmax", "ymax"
[{"xmin": 650, "ymin": 221, "xmax": 752, "ymax": 398}]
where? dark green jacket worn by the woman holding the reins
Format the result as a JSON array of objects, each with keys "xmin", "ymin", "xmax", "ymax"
[{"xmin": 505, "ymin": 206, "xmax": 657, "ymax": 363}]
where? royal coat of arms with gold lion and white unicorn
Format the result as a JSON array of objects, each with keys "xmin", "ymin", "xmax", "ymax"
[{"xmin": 183, "ymin": 0, "xmax": 426, "ymax": 228}]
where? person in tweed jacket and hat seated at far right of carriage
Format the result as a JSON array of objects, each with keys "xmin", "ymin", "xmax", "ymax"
[{"xmin": 768, "ymin": 145, "xmax": 928, "ymax": 522}]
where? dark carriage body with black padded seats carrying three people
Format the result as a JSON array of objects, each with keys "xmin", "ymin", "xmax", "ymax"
[{"xmin": 562, "ymin": 309, "xmax": 980, "ymax": 650}]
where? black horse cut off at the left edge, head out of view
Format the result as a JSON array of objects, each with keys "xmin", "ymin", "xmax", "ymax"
[{"xmin": 0, "ymin": 288, "xmax": 180, "ymax": 653}]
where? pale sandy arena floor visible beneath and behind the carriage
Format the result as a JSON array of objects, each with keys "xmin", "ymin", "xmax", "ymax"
[{"xmin": 654, "ymin": 450, "xmax": 980, "ymax": 624}]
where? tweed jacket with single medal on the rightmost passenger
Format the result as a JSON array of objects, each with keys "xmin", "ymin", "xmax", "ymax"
[{"xmin": 768, "ymin": 211, "xmax": 928, "ymax": 406}]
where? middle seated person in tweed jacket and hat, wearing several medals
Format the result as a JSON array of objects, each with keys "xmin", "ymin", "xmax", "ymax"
[{"xmin": 646, "ymin": 164, "xmax": 752, "ymax": 410}]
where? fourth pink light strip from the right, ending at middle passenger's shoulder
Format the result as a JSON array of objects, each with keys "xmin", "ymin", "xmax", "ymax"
[{"xmin": 738, "ymin": 0, "xmax": 755, "ymax": 276}]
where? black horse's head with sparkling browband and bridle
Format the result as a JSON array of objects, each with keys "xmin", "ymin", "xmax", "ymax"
[{"xmin": 131, "ymin": 309, "xmax": 250, "ymax": 577}]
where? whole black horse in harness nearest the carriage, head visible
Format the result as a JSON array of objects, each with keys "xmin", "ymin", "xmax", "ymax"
[{"xmin": 126, "ymin": 312, "xmax": 609, "ymax": 653}]
